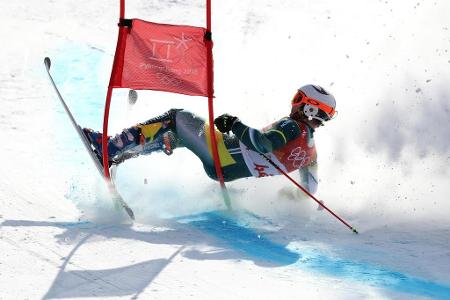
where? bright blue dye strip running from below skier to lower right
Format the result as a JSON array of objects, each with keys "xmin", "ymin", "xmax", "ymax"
[{"xmin": 178, "ymin": 211, "xmax": 450, "ymax": 299}]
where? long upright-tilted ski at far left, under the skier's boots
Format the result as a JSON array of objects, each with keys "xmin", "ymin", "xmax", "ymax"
[{"xmin": 44, "ymin": 57, "xmax": 134, "ymax": 220}]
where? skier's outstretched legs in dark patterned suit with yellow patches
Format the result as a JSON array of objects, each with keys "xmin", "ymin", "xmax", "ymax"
[{"xmin": 84, "ymin": 109, "xmax": 251, "ymax": 181}]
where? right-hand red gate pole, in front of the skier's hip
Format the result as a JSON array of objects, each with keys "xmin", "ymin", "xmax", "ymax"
[{"xmin": 206, "ymin": 0, "xmax": 231, "ymax": 209}]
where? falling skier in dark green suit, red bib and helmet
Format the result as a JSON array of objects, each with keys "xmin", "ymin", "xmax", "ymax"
[{"xmin": 83, "ymin": 85, "xmax": 336, "ymax": 193}]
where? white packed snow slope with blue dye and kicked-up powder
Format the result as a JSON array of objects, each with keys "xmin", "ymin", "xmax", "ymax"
[{"xmin": 0, "ymin": 0, "xmax": 450, "ymax": 299}]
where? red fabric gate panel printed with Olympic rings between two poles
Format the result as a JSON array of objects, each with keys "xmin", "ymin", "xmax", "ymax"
[{"xmin": 110, "ymin": 19, "xmax": 209, "ymax": 97}]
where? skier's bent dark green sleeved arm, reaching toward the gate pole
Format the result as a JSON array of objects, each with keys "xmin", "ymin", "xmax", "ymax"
[{"xmin": 231, "ymin": 118, "xmax": 300, "ymax": 153}]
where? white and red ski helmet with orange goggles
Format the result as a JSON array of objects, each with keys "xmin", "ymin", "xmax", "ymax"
[{"xmin": 291, "ymin": 84, "xmax": 336, "ymax": 122}]
